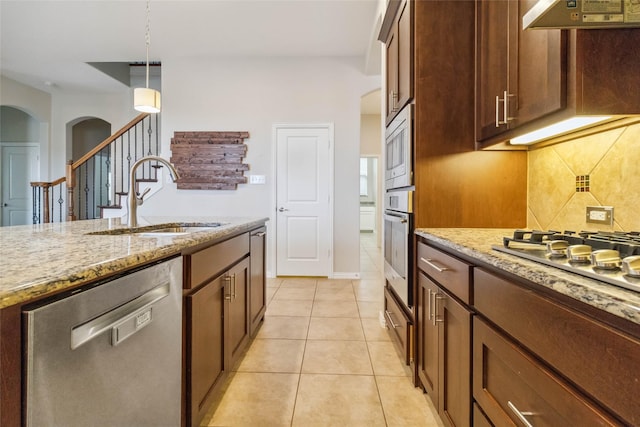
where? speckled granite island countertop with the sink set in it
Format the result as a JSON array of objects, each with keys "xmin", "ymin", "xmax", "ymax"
[{"xmin": 0, "ymin": 217, "xmax": 268, "ymax": 308}]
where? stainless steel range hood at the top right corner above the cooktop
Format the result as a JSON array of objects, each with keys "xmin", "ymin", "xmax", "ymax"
[{"xmin": 522, "ymin": 0, "xmax": 640, "ymax": 29}]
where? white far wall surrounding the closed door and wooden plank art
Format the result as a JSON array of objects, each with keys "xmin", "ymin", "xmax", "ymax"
[{"xmin": 139, "ymin": 58, "xmax": 380, "ymax": 277}]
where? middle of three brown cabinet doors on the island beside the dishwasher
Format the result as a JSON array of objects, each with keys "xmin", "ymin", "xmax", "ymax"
[{"xmin": 227, "ymin": 257, "xmax": 250, "ymax": 366}]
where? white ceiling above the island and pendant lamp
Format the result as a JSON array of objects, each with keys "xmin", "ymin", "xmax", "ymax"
[{"xmin": 0, "ymin": 0, "xmax": 381, "ymax": 92}]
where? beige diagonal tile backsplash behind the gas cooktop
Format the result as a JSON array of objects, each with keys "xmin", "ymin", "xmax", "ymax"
[{"xmin": 527, "ymin": 123, "xmax": 640, "ymax": 231}]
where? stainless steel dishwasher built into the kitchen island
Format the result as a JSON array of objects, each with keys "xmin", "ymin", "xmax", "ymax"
[{"xmin": 24, "ymin": 257, "xmax": 182, "ymax": 427}]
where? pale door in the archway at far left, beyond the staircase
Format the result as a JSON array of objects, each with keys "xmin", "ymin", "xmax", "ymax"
[{"xmin": 0, "ymin": 144, "xmax": 40, "ymax": 226}]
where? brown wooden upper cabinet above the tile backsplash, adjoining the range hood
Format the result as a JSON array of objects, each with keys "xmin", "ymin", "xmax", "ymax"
[{"xmin": 475, "ymin": 0, "xmax": 640, "ymax": 149}]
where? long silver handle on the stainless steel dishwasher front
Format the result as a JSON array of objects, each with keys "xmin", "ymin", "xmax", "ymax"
[{"xmin": 71, "ymin": 282, "xmax": 170, "ymax": 350}]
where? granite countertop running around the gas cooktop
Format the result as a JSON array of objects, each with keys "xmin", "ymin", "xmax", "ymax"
[{"xmin": 416, "ymin": 228, "xmax": 640, "ymax": 324}]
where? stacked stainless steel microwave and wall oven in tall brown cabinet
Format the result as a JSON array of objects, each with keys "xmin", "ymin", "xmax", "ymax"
[{"xmin": 384, "ymin": 104, "xmax": 414, "ymax": 310}]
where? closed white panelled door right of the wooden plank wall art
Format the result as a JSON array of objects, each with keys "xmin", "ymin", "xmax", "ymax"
[{"xmin": 275, "ymin": 125, "xmax": 333, "ymax": 277}]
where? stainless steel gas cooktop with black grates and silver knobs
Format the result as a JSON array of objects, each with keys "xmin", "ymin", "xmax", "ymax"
[{"xmin": 492, "ymin": 230, "xmax": 640, "ymax": 292}]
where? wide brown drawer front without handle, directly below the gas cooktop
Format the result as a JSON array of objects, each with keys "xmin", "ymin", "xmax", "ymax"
[{"xmin": 474, "ymin": 268, "xmax": 640, "ymax": 425}]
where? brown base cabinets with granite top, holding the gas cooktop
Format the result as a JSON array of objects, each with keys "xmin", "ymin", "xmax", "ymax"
[{"xmin": 414, "ymin": 228, "xmax": 640, "ymax": 426}]
